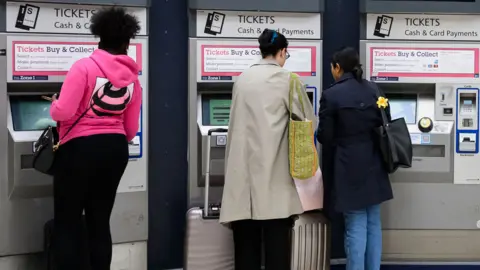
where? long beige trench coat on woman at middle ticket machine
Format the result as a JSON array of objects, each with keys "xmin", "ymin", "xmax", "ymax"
[{"xmin": 220, "ymin": 60, "xmax": 316, "ymax": 223}]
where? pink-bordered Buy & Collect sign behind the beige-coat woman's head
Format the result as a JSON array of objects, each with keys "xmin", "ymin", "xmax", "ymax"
[{"xmin": 201, "ymin": 45, "xmax": 317, "ymax": 80}]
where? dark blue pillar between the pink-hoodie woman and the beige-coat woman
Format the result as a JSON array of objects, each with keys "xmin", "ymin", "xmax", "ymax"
[{"xmin": 148, "ymin": 0, "xmax": 188, "ymax": 270}]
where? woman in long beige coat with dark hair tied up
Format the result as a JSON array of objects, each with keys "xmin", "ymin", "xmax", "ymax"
[{"xmin": 220, "ymin": 29, "xmax": 315, "ymax": 270}]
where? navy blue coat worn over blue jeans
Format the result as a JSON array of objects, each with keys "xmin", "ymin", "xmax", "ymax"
[{"xmin": 317, "ymin": 73, "xmax": 393, "ymax": 212}]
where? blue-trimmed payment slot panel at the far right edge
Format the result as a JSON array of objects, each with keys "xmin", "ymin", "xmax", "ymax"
[{"xmin": 456, "ymin": 89, "xmax": 478, "ymax": 153}]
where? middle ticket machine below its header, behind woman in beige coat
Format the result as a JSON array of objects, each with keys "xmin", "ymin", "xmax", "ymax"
[{"xmin": 188, "ymin": 38, "xmax": 321, "ymax": 206}]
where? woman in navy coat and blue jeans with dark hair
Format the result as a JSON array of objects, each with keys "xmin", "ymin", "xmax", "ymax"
[{"xmin": 317, "ymin": 48, "xmax": 393, "ymax": 270}]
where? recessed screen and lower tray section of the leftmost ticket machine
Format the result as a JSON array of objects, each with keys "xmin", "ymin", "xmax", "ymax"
[{"xmin": 7, "ymin": 83, "xmax": 61, "ymax": 198}]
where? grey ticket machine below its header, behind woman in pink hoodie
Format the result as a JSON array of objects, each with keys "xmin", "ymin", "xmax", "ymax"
[{"xmin": 0, "ymin": 34, "xmax": 148, "ymax": 256}]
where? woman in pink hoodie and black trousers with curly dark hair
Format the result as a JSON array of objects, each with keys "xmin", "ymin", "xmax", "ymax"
[{"xmin": 50, "ymin": 7, "xmax": 142, "ymax": 270}]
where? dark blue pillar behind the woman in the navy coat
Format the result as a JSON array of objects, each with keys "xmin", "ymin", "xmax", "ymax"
[{"xmin": 323, "ymin": 0, "xmax": 360, "ymax": 258}]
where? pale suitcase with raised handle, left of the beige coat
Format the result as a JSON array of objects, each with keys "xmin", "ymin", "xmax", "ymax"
[{"xmin": 184, "ymin": 128, "xmax": 235, "ymax": 270}]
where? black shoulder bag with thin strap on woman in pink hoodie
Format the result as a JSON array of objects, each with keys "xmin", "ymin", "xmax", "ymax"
[{"xmin": 33, "ymin": 80, "xmax": 105, "ymax": 175}]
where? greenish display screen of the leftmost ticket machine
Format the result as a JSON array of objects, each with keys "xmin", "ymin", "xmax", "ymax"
[{"xmin": 10, "ymin": 95, "xmax": 57, "ymax": 131}]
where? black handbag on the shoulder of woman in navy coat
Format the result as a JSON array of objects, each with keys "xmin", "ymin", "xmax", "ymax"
[{"xmin": 374, "ymin": 85, "xmax": 413, "ymax": 173}]
